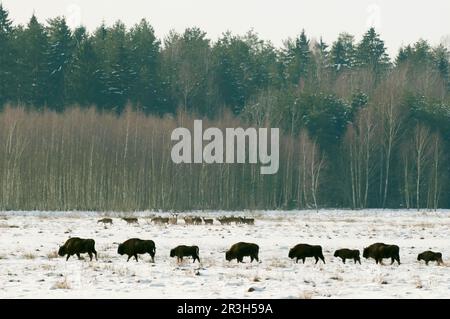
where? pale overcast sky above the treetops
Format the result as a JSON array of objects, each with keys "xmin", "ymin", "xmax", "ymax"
[{"xmin": 0, "ymin": 0, "xmax": 450, "ymax": 55}]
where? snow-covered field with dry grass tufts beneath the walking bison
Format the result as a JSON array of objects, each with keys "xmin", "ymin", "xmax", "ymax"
[{"xmin": 0, "ymin": 210, "xmax": 450, "ymax": 299}]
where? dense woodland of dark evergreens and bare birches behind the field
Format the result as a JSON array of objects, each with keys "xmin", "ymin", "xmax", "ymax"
[{"xmin": 0, "ymin": 5, "xmax": 450, "ymax": 210}]
